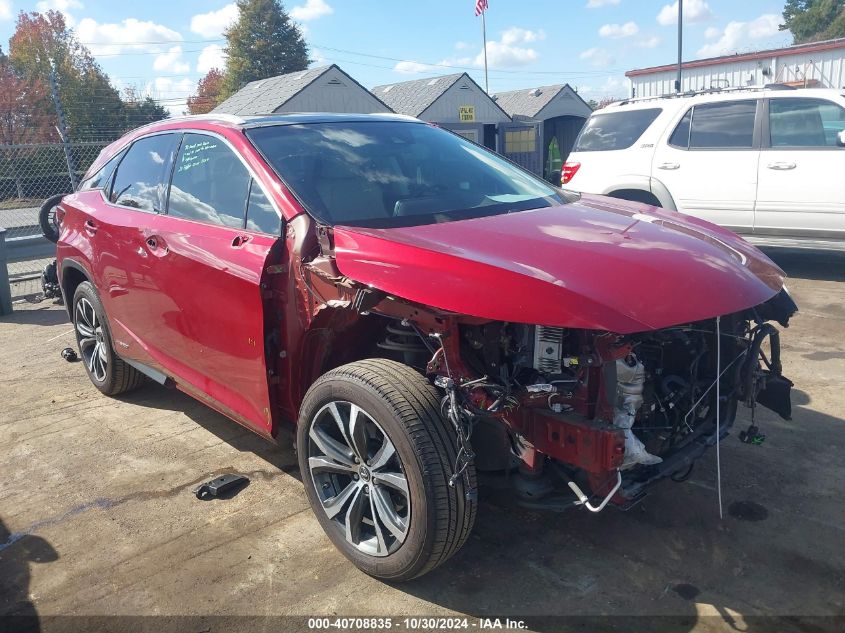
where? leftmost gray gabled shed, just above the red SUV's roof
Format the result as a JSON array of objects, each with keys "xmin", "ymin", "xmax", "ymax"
[{"xmin": 214, "ymin": 64, "xmax": 391, "ymax": 115}]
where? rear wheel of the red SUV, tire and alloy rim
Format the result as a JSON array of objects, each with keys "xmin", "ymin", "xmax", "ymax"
[{"xmin": 71, "ymin": 281, "xmax": 144, "ymax": 396}]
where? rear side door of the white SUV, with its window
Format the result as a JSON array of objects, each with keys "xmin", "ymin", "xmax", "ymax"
[{"xmin": 652, "ymin": 99, "xmax": 762, "ymax": 233}]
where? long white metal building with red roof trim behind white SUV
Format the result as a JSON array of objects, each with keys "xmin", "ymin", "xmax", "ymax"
[{"xmin": 625, "ymin": 38, "xmax": 845, "ymax": 97}]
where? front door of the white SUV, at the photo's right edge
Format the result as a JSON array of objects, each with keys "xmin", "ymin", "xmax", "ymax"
[{"xmin": 754, "ymin": 97, "xmax": 845, "ymax": 239}]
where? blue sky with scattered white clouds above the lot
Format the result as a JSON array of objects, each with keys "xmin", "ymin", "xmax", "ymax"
[{"xmin": 0, "ymin": 0, "xmax": 791, "ymax": 112}]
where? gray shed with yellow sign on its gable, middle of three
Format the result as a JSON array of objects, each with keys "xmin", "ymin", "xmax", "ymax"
[{"xmin": 372, "ymin": 73, "xmax": 511, "ymax": 149}]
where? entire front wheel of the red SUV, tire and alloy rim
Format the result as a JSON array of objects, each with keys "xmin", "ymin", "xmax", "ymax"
[{"xmin": 297, "ymin": 359, "xmax": 477, "ymax": 580}]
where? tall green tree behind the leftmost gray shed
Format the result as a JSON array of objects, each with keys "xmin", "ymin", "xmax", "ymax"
[{"xmin": 223, "ymin": 0, "xmax": 311, "ymax": 97}]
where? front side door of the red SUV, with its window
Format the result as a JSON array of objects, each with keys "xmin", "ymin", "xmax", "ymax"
[{"xmin": 141, "ymin": 133, "xmax": 283, "ymax": 434}]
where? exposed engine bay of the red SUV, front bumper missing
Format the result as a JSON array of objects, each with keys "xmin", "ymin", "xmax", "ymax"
[{"xmin": 350, "ymin": 291, "xmax": 796, "ymax": 510}]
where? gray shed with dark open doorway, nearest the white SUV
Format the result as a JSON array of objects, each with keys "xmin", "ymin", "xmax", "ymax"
[{"xmin": 493, "ymin": 84, "xmax": 592, "ymax": 180}]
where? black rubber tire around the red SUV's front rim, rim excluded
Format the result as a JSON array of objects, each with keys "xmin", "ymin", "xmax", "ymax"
[{"xmin": 297, "ymin": 359, "xmax": 478, "ymax": 581}]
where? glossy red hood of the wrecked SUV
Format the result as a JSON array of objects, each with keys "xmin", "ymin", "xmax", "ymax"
[{"xmin": 334, "ymin": 195, "xmax": 784, "ymax": 334}]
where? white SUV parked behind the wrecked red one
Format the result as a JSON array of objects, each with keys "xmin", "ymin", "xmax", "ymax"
[{"xmin": 562, "ymin": 88, "xmax": 845, "ymax": 249}]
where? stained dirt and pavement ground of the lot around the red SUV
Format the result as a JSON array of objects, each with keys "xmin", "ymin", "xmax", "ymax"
[{"xmin": 0, "ymin": 249, "xmax": 845, "ymax": 631}]
